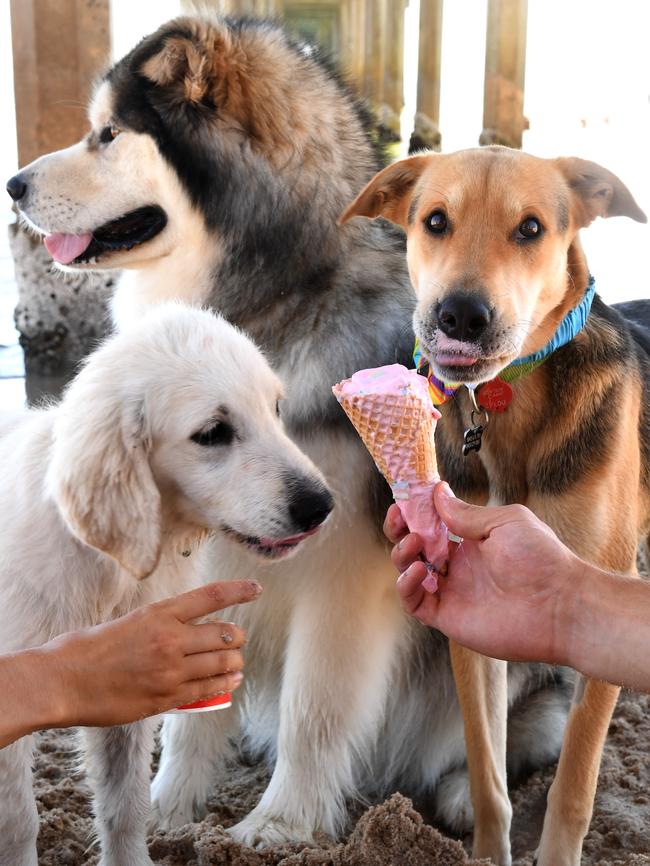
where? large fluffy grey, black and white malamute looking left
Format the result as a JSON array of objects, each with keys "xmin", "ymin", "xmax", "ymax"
[{"xmin": 7, "ymin": 18, "xmax": 566, "ymax": 843}]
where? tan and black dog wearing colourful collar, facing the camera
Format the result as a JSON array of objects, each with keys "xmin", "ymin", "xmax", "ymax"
[{"xmin": 342, "ymin": 147, "xmax": 650, "ymax": 866}]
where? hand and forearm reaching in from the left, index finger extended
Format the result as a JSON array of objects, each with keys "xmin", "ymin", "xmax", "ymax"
[{"xmin": 0, "ymin": 580, "xmax": 262, "ymax": 748}]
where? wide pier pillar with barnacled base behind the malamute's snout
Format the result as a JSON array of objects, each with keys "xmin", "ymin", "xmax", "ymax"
[{"xmin": 10, "ymin": 0, "xmax": 115, "ymax": 374}]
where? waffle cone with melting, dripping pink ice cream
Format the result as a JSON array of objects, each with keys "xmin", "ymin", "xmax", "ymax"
[{"xmin": 332, "ymin": 364, "xmax": 448, "ymax": 592}]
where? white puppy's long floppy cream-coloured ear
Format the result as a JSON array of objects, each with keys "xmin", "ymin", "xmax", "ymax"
[{"xmin": 48, "ymin": 395, "xmax": 161, "ymax": 580}]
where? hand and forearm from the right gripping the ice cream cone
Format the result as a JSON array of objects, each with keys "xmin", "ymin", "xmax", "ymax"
[{"xmin": 385, "ymin": 483, "xmax": 650, "ymax": 692}]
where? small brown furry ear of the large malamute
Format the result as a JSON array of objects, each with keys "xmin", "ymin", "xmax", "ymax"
[{"xmin": 140, "ymin": 35, "xmax": 212, "ymax": 103}]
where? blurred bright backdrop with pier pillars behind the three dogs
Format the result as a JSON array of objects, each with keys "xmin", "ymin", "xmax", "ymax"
[{"xmin": 0, "ymin": 0, "xmax": 650, "ymax": 407}]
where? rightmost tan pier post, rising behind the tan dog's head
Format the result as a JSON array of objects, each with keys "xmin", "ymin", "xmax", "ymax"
[{"xmin": 479, "ymin": 0, "xmax": 528, "ymax": 147}]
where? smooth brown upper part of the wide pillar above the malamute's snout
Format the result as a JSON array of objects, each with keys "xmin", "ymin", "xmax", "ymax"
[{"xmin": 11, "ymin": 0, "xmax": 110, "ymax": 166}]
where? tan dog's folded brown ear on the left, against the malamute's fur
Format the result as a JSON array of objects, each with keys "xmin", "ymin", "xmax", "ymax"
[{"xmin": 339, "ymin": 154, "xmax": 435, "ymax": 228}]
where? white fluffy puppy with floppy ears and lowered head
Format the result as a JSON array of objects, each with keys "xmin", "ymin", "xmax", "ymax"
[{"xmin": 0, "ymin": 304, "xmax": 332, "ymax": 866}]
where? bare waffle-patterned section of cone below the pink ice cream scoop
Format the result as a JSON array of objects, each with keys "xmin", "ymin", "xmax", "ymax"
[{"xmin": 339, "ymin": 394, "xmax": 438, "ymax": 486}]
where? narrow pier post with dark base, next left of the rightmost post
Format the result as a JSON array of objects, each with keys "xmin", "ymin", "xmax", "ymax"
[{"xmin": 409, "ymin": 0, "xmax": 443, "ymax": 152}]
